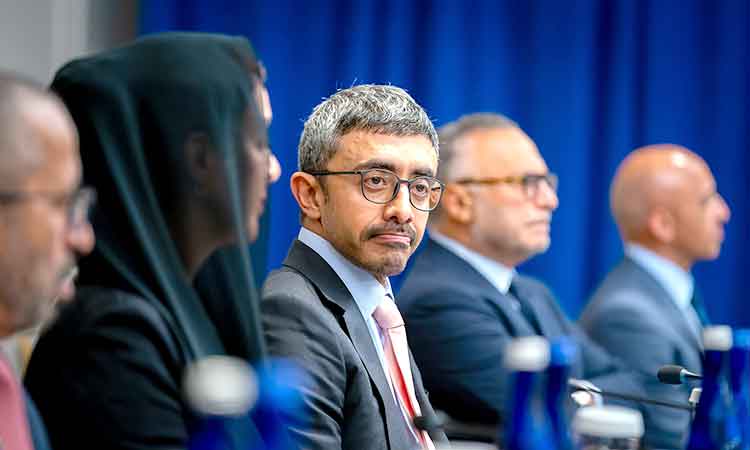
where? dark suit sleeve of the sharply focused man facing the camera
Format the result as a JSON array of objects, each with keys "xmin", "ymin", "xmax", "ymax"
[{"xmin": 261, "ymin": 273, "xmax": 347, "ymax": 450}]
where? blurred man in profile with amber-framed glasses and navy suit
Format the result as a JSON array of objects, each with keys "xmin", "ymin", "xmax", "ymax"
[{"xmin": 398, "ymin": 114, "xmax": 629, "ymax": 432}]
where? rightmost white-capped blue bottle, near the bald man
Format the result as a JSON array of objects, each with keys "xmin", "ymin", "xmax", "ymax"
[{"xmin": 687, "ymin": 325, "xmax": 736, "ymax": 450}]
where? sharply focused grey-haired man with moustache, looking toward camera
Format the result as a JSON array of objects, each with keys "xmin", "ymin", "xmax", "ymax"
[{"xmin": 261, "ymin": 85, "xmax": 444, "ymax": 450}]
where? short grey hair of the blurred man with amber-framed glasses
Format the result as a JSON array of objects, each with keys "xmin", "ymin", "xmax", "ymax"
[{"xmin": 437, "ymin": 113, "xmax": 518, "ymax": 181}]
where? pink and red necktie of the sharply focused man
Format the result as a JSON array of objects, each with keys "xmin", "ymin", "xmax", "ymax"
[{"xmin": 372, "ymin": 297, "xmax": 435, "ymax": 450}]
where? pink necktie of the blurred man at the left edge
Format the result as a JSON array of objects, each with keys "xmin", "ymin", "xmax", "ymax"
[{"xmin": 0, "ymin": 351, "xmax": 34, "ymax": 450}]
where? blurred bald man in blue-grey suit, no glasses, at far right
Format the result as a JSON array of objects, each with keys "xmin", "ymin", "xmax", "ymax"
[{"xmin": 581, "ymin": 144, "xmax": 730, "ymax": 449}]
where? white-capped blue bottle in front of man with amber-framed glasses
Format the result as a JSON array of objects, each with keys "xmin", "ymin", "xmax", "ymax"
[{"xmin": 502, "ymin": 336, "xmax": 555, "ymax": 450}]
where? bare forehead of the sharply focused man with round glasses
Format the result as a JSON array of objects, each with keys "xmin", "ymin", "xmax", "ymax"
[{"xmin": 332, "ymin": 130, "xmax": 437, "ymax": 174}]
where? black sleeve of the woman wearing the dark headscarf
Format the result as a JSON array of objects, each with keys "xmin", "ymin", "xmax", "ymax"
[{"xmin": 25, "ymin": 291, "xmax": 187, "ymax": 450}]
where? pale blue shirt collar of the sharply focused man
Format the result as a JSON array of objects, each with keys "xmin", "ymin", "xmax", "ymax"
[{"xmin": 297, "ymin": 227, "xmax": 394, "ymax": 318}]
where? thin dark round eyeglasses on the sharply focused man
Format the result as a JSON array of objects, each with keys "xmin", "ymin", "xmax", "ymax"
[{"xmin": 307, "ymin": 169, "xmax": 445, "ymax": 211}]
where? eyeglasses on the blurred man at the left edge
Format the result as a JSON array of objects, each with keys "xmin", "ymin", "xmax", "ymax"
[{"xmin": 0, "ymin": 186, "xmax": 96, "ymax": 228}]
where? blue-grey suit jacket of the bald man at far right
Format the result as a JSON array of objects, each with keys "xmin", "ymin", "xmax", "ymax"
[{"xmin": 580, "ymin": 257, "xmax": 702, "ymax": 449}]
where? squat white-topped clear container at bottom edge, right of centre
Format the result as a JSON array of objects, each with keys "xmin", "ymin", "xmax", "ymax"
[{"xmin": 573, "ymin": 405, "xmax": 643, "ymax": 450}]
